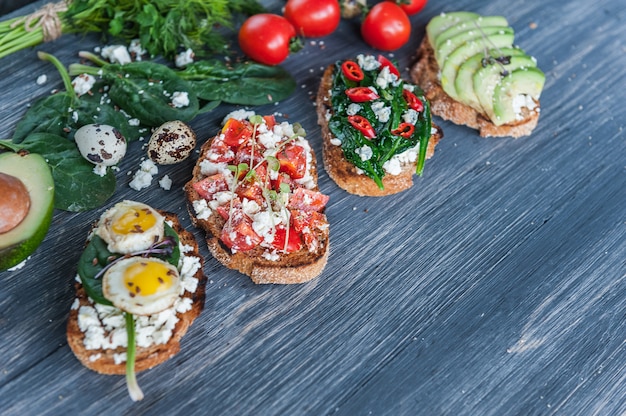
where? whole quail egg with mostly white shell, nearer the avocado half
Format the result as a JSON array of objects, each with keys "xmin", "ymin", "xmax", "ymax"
[{"xmin": 74, "ymin": 124, "xmax": 126, "ymax": 166}]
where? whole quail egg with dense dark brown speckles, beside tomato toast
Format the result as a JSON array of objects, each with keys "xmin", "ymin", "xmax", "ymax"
[{"xmin": 148, "ymin": 120, "xmax": 196, "ymax": 165}]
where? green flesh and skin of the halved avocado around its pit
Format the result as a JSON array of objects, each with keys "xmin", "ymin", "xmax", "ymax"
[{"xmin": 0, "ymin": 152, "xmax": 54, "ymax": 271}]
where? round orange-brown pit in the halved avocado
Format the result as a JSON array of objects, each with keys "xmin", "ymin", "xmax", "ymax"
[{"xmin": 0, "ymin": 172, "xmax": 30, "ymax": 234}]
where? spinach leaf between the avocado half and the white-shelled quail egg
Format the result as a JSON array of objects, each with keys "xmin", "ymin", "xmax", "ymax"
[{"xmin": 20, "ymin": 133, "xmax": 116, "ymax": 212}]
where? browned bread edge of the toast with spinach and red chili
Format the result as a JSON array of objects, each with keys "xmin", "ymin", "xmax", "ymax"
[{"xmin": 316, "ymin": 65, "xmax": 443, "ymax": 196}]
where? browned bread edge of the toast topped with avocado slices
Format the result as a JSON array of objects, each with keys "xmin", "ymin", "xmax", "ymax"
[{"xmin": 410, "ymin": 37, "xmax": 539, "ymax": 138}]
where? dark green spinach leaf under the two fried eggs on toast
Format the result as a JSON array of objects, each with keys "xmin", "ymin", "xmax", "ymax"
[{"xmin": 78, "ymin": 222, "xmax": 180, "ymax": 305}]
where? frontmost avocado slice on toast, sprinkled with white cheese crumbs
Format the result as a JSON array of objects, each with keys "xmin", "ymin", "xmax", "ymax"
[{"xmin": 492, "ymin": 67, "xmax": 546, "ymax": 126}]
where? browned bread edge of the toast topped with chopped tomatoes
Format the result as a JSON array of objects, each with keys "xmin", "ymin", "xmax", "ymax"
[{"xmin": 184, "ymin": 136, "xmax": 330, "ymax": 284}]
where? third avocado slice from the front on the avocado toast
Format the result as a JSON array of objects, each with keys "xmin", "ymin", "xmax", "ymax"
[{"xmin": 454, "ymin": 48, "xmax": 526, "ymax": 112}]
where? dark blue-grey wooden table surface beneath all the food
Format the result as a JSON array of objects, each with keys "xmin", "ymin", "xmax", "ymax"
[{"xmin": 0, "ymin": 0, "xmax": 626, "ymax": 415}]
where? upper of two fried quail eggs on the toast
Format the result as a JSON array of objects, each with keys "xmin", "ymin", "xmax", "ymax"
[{"xmin": 96, "ymin": 200, "xmax": 165, "ymax": 254}]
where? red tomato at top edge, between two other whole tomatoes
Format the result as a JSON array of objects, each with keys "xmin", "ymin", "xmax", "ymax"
[{"xmin": 284, "ymin": 0, "xmax": 341, "ymax": 38}]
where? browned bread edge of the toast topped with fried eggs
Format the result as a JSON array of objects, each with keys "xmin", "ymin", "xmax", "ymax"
[{"xmin": 67, "ymin": 211, "xmax": 206, "ymax": 374}]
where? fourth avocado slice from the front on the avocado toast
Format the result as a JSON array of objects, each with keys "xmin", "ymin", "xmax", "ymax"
[{"xmin": 441, "ymin": 28, "xmax": 514, "ymax": 100}]
